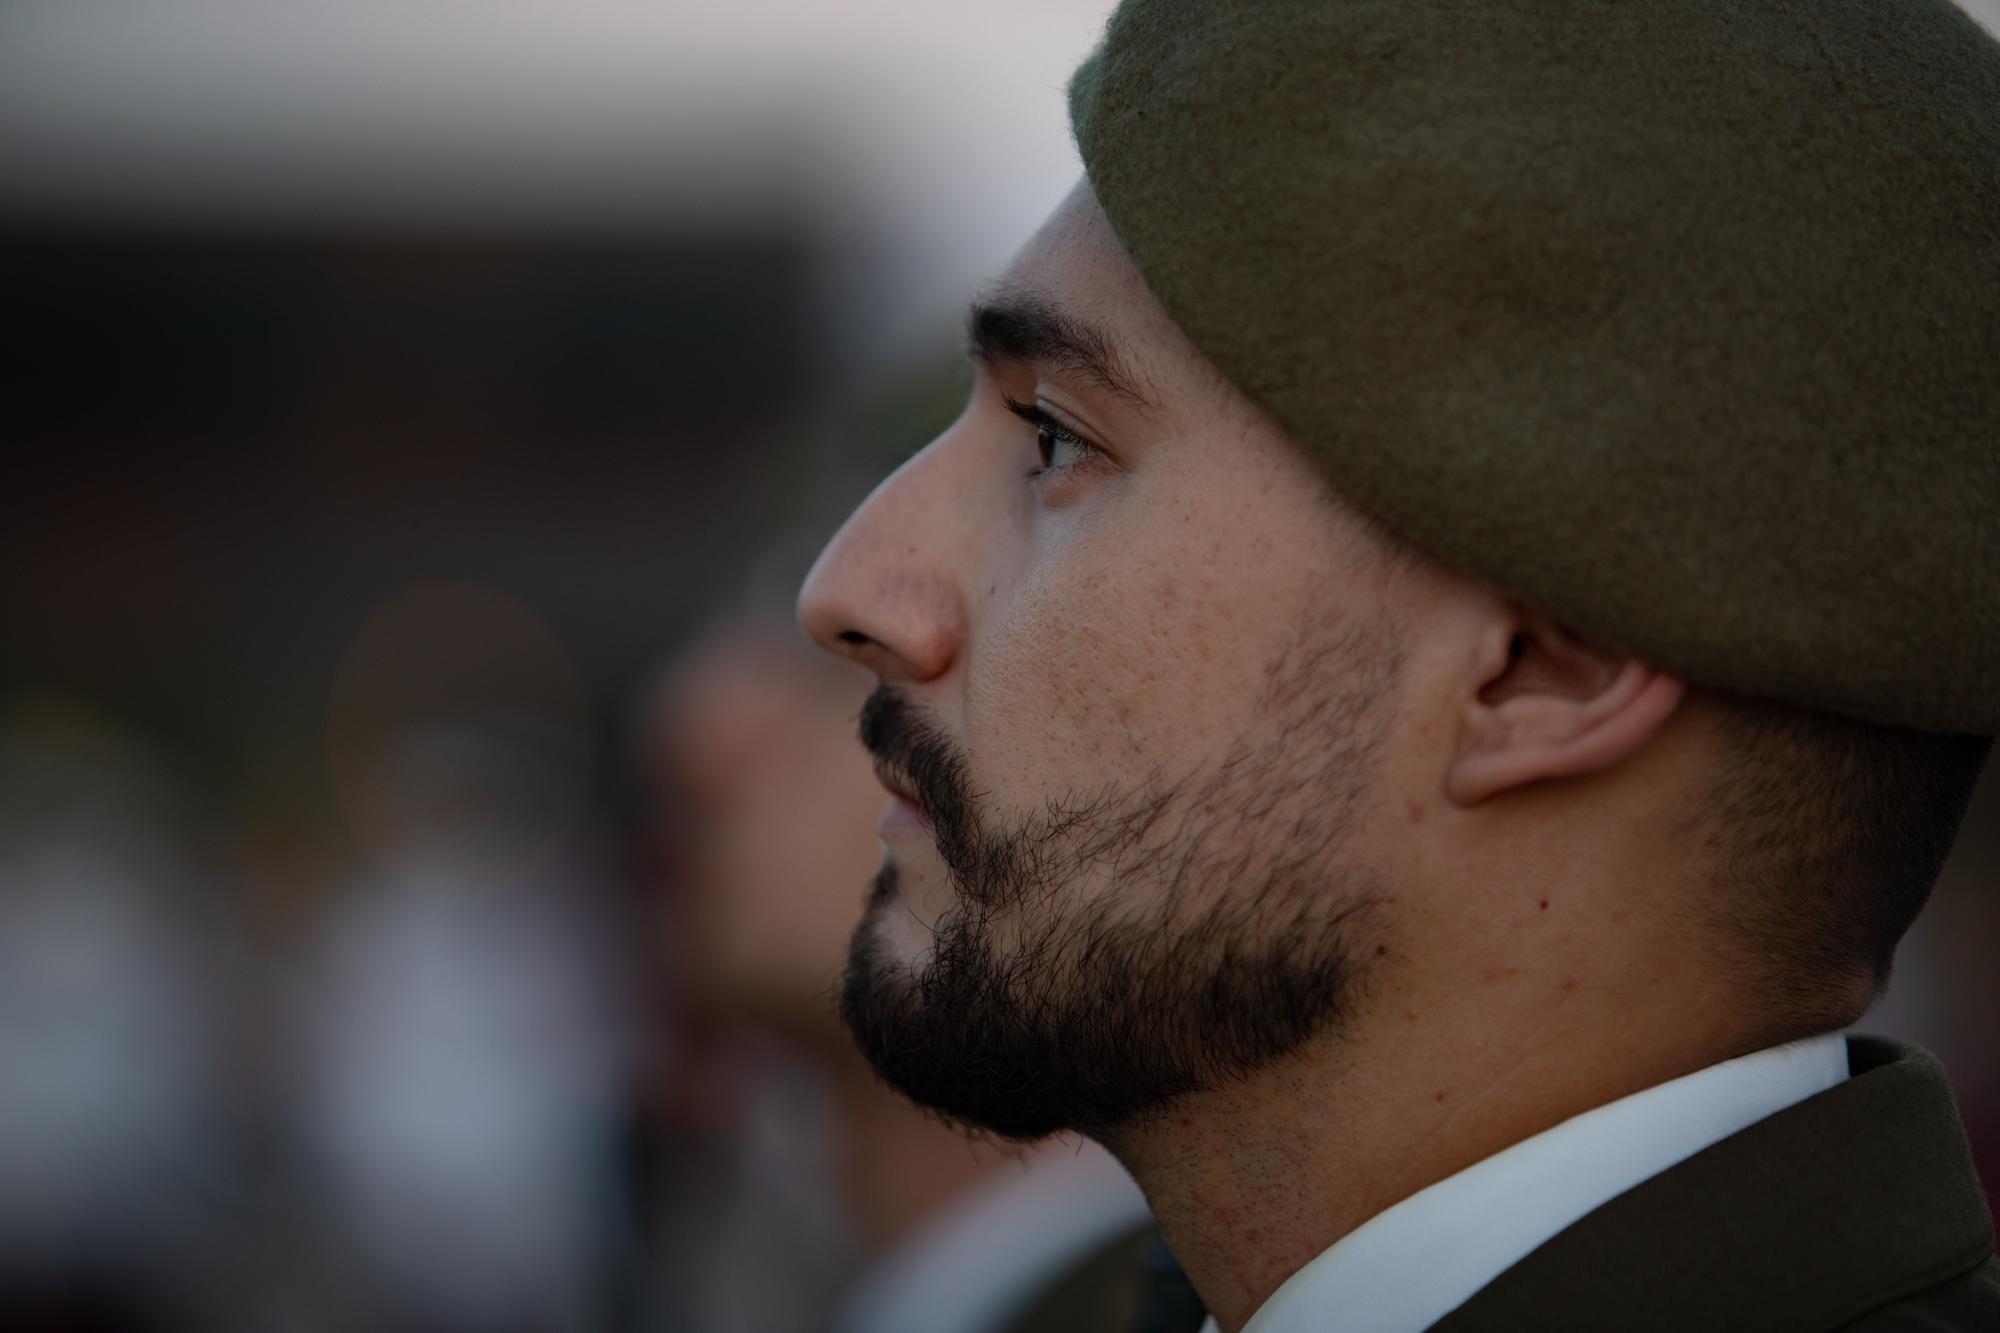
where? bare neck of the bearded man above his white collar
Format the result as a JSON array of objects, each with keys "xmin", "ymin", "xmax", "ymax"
[{"xmin": 1104, "ymin": 924, "xmax": 1764, "ymax": 1333}]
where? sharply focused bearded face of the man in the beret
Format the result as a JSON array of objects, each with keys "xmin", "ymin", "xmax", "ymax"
[{"xmin": 800, "ymin": 186, "xmax": 1446, "ymax": 1139}]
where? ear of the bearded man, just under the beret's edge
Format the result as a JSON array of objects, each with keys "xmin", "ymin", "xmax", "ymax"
[{"xmin": 1444, "ymin": 608, "xmax": 1688, "ymax": 807}]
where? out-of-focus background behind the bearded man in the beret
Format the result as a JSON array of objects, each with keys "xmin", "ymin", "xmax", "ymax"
[{"xmin": 0, "ymin": 0, "xmax": 2000, "ymax": 1333}]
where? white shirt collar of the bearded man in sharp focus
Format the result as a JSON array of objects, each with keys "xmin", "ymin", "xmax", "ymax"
[{"xmin": 1204, "ymin": 1033, "xmax": 1848, "ymax": 1333}]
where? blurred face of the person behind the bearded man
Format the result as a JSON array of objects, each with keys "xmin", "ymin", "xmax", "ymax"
[{"xmin": 654, "ymin": 620, "xmax": 882, "ymax": 1039}]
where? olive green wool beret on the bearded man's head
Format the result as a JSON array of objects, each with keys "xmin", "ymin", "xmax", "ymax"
[{"xmin": 1070, "ymin": 0, "xmax": 2000, "ymax": 735}]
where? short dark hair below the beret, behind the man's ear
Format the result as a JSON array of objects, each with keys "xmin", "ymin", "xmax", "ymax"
[{"xmin": 1710, "ymin": 695, "xmax": 1992, "ymax": 1012}]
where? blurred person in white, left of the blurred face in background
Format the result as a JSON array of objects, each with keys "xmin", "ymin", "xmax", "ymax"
[{"xmin": 296, "ymin": 584, "xmax": 634, "ymax": 1333}]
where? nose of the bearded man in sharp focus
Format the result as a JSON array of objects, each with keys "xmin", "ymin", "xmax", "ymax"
[{"xmin": 798, "ymin": 436, "xmax": 972, "ymax": 683}]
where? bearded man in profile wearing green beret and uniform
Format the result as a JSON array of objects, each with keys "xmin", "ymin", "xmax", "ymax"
[{"xmin": 800, "ymin": 0, "xmax": 2000, "ymax": 1333}]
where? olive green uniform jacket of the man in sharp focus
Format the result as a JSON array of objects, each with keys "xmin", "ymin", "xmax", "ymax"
[{"xmin": 1434, "ymin": 1037, "xmax": 2000, "ymax": 1333}]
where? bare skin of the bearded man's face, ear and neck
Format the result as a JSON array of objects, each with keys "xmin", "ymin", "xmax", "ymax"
[{"xmin": 800, "ymin": 182, "xmax": 1868, "ymax": 1333}]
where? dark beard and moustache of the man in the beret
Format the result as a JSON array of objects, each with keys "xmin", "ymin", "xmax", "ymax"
[{"xmin": 840, "ymin": 616, "xmax": 1398, "ymax": 1141}]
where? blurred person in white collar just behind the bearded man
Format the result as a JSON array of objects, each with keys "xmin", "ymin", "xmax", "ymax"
[{"xmin": 648, "ymin": 552, "xmax": 1152, "ymax": 1333}]
